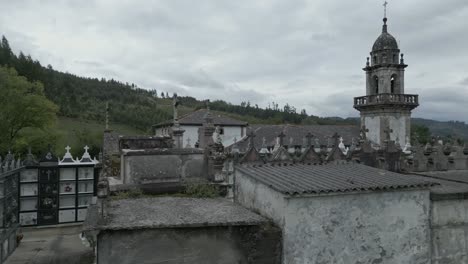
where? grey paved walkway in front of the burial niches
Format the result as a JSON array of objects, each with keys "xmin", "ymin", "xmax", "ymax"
[{"xmin": 5, "ymin": 225, "xmax": 93, "ymax": 264}]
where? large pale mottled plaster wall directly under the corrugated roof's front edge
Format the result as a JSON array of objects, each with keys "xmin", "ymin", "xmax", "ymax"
[{"xmin": 283, "ymin": 191, "xmax": 430, "ymax": 264}]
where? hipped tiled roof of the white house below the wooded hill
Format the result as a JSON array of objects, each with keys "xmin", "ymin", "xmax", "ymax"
[{"xmin": 156, "ymin": 109, "xmax": 248, "ymax": 127}]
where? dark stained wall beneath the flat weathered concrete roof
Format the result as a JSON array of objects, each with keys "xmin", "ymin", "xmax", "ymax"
[{"xmin": 97, "ymin": 226, "xmax": 281, "ymax": 264}]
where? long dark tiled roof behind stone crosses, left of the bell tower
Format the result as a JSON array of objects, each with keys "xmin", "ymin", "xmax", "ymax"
[{"xmin": 232, "ymin": 125, "xmax": 360, "ymax": 149}]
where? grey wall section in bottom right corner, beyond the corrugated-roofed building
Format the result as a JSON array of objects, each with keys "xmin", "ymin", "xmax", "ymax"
[{"xmin": 431, "ymin": 199, "xmax": 468, "ymax": 264}]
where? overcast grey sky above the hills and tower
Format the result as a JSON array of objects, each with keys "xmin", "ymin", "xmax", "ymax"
[{"xmin": 0, "ymin": 0, "xmax": 468, "ymax": 122}]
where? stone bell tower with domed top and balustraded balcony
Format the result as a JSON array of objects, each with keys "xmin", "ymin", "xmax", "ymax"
[{"xmin": 354, "ymin": 12, "xmax": 419, "ymax": 147}]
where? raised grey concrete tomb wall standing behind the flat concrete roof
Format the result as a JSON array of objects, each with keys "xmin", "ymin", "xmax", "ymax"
[{"xmin": 122, "ymin": 150, "xmax": 206, "ymax": 184}]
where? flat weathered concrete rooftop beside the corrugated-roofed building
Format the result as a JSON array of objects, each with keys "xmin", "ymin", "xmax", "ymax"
[{"xmin": 85, "ymin": 197, "xmax": 268, "ymax": 230}]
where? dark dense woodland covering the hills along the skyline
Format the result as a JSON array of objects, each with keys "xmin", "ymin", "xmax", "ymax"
[{"xmin": 0, "ymin": 36, "xmax": 468, "ymax": 156}]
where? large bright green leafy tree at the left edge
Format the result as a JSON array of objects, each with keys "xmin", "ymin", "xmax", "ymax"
[{"xmin": 0, "ymin": 67, "xmax": 58, "ymax": 152}]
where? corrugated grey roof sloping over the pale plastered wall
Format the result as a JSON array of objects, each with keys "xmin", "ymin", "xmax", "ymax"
[{"xmin": 236, "ymin": 162, "xmax": 438, "ymax": 195}]
